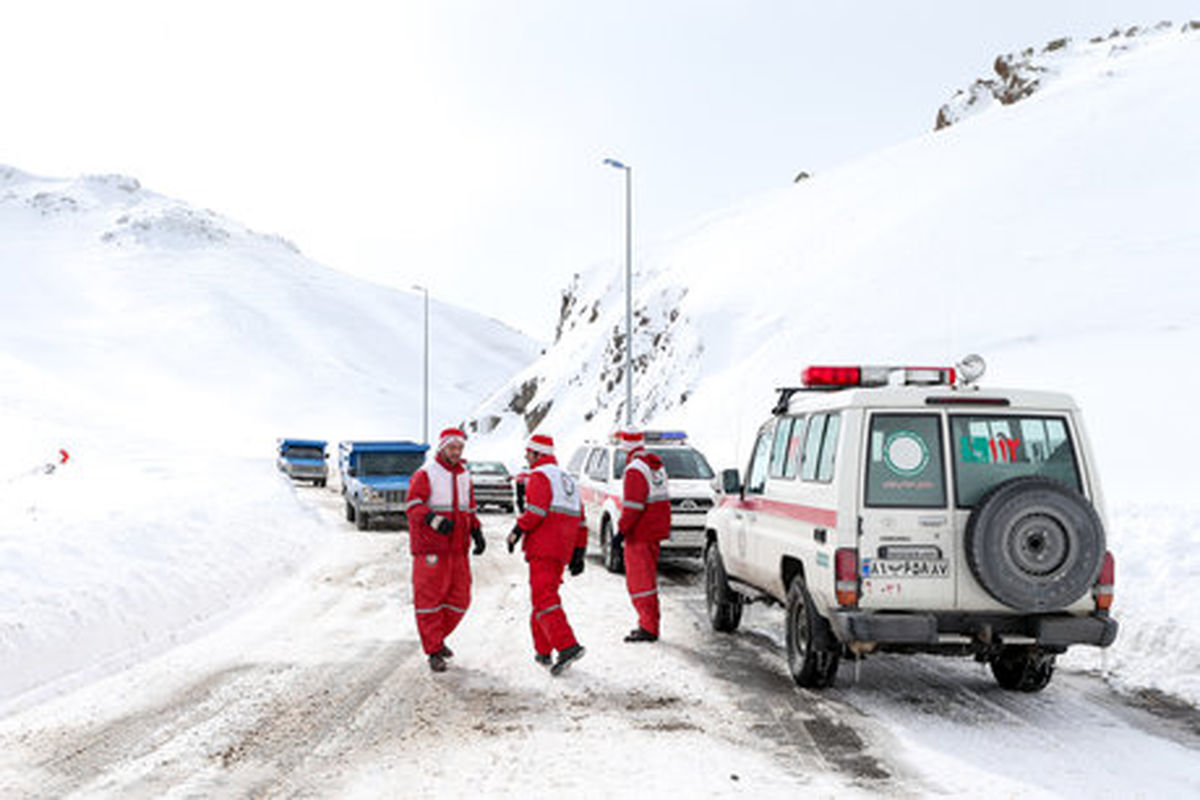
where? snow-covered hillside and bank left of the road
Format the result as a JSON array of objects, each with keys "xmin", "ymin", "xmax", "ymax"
[{"xmin": 0, "ymin": 172, "xmax": 539, "ymax": 699}]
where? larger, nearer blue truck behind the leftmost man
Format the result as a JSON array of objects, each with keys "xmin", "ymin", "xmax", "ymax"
[{"xmin": 337, "ymin": 441, "xmax": 430, "ymax": 530}]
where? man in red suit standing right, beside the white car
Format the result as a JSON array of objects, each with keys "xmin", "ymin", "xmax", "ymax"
[{"xmin": 613, "ymin": 431, "xmax": 671, "ymax": 642}]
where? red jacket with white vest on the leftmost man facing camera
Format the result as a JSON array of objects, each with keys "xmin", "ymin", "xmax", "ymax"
[{"xmin": 404, "ymin": 453, "xmax": 480, "ymax": 555}]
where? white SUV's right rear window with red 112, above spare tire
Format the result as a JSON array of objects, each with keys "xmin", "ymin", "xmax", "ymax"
[{"xmin": 950, "ymin": 415, "xmax": 1082, "ymax": 509}]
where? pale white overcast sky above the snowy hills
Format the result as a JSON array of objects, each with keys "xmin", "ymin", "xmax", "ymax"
[{"xmin": 0, "ymin": 0, "xmax": 1200, "ymax": 338}]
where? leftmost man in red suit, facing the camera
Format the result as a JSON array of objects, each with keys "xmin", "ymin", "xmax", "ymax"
[{"xmin": 404, "ymin": 428, "xmax": 487, "ymax": 672}]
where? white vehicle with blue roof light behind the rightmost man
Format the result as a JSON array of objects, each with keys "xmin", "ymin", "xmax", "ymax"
[{"xmin": 566, "ymin": 431, "xmax": 714, "ymax": 572}]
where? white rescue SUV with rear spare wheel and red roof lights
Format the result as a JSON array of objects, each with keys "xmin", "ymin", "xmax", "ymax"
[{"xmin": 704, "ymin": 357, "xmax": 1117, "ymax": 692}]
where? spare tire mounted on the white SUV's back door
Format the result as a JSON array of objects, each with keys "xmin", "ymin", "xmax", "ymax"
[{"xmin": 965, "ymin": 477, "xmax": 1105, "ymax": 613}]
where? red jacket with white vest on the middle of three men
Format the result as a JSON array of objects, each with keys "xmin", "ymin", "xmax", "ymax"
[{"xmin": 517, "ymin": 456, "xmax": 588, "ymax": 563}]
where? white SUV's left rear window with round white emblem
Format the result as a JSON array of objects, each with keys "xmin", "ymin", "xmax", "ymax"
[{"xmin": 866, "ymin": 414, "xmax": 946, "ymax": 509}]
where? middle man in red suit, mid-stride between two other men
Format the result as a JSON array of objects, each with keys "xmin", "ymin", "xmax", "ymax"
[{"xmin": 508, "ymin": 434, "xmax": 588, "ymax": 675}]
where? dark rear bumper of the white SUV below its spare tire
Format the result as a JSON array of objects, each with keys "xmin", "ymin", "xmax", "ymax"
[{"xmin": 830, "ymin": 610, "xmax": 1118, "ymax": 648}]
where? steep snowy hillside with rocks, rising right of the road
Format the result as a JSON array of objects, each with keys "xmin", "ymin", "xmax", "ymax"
[{"xmin": 465, "ymin": 25, "xmax": 1200, "ymax": 699}]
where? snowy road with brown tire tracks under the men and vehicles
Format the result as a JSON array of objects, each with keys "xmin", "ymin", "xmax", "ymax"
[{"xmin": 0, "ymin": 491, "xmax": 1200, "ymax": 798}]
